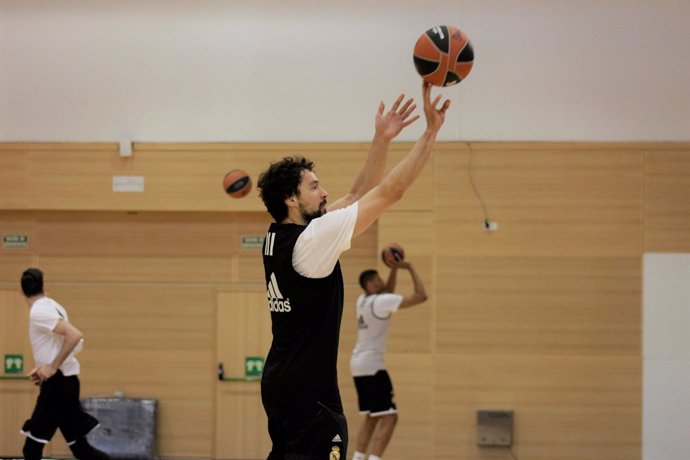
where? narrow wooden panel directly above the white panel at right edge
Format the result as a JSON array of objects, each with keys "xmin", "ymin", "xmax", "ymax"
[{"xmin": 645, "ymin": 148, "xmax": 690, "ymax": 252}]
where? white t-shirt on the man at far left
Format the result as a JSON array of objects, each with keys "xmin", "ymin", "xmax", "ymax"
[{"xmin": 29, "ymin": 297, "xmax": 83, "ymax": 376}]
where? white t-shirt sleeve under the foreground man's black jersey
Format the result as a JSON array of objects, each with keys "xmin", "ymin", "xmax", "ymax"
[{"xmin": 292, "ymin": 202, "xmax": 359, "ymax": 278}]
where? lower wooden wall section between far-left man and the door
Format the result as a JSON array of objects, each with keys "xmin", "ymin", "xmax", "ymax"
[{"xmin": 48, "ymin": 282, "xmax": 216, "ymax": 457}]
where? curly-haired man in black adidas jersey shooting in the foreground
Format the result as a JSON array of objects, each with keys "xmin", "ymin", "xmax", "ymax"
[{"xmin": 258, "ymin": 84, "xmax": 450, "ymax": 460}]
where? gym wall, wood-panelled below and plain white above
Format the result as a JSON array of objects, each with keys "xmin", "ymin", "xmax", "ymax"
[{"xmin": 0, "ymin": 0, "xmax": 690, "ymax": 460}]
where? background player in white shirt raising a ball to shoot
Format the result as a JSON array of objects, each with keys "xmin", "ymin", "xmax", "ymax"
[{"xmin": 350, "ymin": 261, "xmax": 427, "ymax": 460}]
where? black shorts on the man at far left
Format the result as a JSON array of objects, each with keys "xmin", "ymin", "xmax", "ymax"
[{"xmin": 21, "ymin": 371, "xmax": 98, "ymax": 445}]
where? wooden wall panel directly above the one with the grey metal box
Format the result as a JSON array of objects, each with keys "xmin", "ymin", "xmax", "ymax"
[{"xmin": 436, "ymin": 257, "xmax": 642, "ymax": 357}]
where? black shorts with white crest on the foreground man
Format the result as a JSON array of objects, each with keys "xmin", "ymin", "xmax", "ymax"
[{"xmin": 267, "ymin": 403, "xmax": 348, "ymax": 460}]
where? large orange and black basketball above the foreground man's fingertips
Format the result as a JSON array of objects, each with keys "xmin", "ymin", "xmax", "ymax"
[{"xmin": 413, "ymin": 26, "xmax": 474, "ymax": 86}]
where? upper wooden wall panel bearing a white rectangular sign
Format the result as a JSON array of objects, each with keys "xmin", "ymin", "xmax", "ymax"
[{"xmin": 30, "ymin": 148, "xmax": 231, "ymax": 210}]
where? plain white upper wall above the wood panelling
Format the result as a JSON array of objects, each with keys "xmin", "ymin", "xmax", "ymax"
[{"xmin": 0, "ymin": 0, "xmax": 690, "ymax": 142}]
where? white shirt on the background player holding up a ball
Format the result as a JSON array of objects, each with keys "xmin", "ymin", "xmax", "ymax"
[{"xmin": 350, "ymin": 293, "xmax": 403, "ymax": 377}]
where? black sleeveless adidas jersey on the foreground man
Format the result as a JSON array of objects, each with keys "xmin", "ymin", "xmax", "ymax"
[{"xmin": 261, "ymin": 223, "xmax": 343, "ymax": 417}]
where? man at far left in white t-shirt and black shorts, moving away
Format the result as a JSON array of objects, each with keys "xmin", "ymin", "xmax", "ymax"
[{"xmin": 21, "ymin": 268, "xmax": 110, "ymax": 460}]
